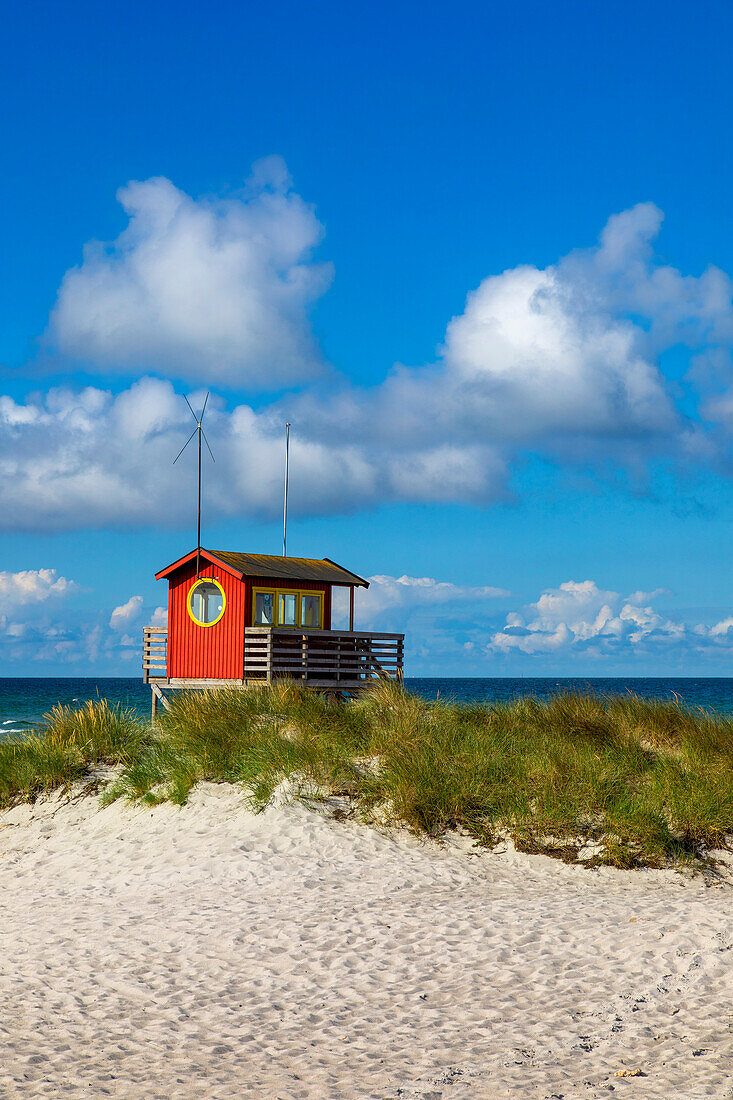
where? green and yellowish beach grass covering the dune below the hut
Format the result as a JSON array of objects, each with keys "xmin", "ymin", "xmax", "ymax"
[{"xmin": 0, "ymin": 682, "xmax": 733, "ymax": 868}]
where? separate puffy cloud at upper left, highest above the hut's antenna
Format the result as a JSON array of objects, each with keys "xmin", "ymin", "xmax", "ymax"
[{"xmin": 50, "ymin": 157, "xmax": 330, "ymax": 388}]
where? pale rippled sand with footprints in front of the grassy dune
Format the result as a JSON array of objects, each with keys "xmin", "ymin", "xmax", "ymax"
[{"xmin": 0, "ymin": 785, "xmax": 733, "ymax": 1100}]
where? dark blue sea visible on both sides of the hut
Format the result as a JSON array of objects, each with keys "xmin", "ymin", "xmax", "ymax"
[{"xmin": 0, "ymin": 677, "xmax": 733, "ymax": 738}]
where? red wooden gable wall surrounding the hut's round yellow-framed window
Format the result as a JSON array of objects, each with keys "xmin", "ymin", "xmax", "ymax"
[{"xmin": 168, "ymin": 558, "xmax": 248, "ymax": 680}]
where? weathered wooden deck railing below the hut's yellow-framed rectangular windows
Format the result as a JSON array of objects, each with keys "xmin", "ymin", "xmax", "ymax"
[{"xmin": 244, "ymin": 626, "xmax": 405, "ymax": 691}]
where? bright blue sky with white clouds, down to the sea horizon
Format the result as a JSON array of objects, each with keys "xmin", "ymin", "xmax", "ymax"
[{"xmin": 0, "ymin": 2, "xmax": 733, "ymax": 675}]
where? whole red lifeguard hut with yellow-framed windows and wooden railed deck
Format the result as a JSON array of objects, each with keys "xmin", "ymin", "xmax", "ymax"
[{"xmin": 143, "ymin": 547, "xmax": 404, "ymax": 714}]
